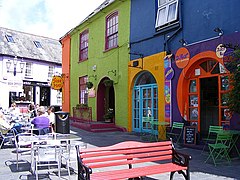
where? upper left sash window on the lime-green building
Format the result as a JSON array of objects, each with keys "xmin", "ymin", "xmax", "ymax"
[{"xmin": 79, "ymin": 30, "xmax": 88, "ymax": 61}]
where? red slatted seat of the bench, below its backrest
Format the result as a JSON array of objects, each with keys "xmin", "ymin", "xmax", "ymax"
[{"xmin": 90, "ymin": 163, "xmax": 187, "ymax": 180}]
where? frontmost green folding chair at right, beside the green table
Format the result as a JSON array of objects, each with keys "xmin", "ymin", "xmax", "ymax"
[{"xmin": 205, "ymin": 131, "xmax": 232, "ymax": 166}]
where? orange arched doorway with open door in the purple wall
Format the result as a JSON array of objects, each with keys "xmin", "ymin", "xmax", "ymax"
[{"xmin": 177, "ymin": 55, "xmax": 230, "ymax": 137}]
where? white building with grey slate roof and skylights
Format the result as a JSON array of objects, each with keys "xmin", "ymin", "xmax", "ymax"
[{"xmin": 0, "ymin": 27, "xmax": 62, "ymax": 111}]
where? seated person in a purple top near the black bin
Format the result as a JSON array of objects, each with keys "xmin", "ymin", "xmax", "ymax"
[{"xmin": 31, "ymin": 106, "xmax": 50, "ymax": 135}]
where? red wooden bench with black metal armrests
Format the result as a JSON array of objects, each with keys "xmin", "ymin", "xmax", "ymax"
[{"xmin": 76, "ymin": 141, "xmax": 191, "ymax": 180}]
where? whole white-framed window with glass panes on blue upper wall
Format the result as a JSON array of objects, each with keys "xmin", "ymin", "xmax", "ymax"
[{"xmin": 155, "ymin": 0, "xmax": 179, "ymax": 28}]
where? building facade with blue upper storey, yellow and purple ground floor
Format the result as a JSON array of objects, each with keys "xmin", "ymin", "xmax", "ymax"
[{"xmin": 128, "ymin": 0, "xmax": 240, "ymax": 136}]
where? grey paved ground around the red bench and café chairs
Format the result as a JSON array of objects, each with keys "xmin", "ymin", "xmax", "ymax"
[{"xmin": 0, "ymin": 127, "xmax": 240, "ymax": 180}]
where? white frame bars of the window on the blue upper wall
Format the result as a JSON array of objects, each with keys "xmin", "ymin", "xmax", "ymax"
[{"xmin": 155, "ymin": 0, "xmax": 179, "ymax": 28}]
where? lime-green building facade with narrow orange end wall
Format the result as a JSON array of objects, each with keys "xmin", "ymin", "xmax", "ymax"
[{"xmin": 60, "ymin": 0, "xmax": 130, "ymax": 128}]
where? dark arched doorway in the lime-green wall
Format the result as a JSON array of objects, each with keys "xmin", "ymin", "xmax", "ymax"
[{"xmin": 97, "ymin": 77, "xmax": 115, "ymax": 123}]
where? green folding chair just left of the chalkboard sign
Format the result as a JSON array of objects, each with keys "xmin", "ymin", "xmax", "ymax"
[{"xmin": 167, "ymin": 122, "xmax": 184, "ymax": 143}]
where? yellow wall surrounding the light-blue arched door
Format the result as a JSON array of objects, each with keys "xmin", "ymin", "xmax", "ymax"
[{"xmin": 128, "ymin": 52, "xmax": 166, "ymax": 131}]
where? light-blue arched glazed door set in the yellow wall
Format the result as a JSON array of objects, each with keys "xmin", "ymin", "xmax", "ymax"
[{"xmin": 132, "ymin": 71, "xmax": 158, "ymax": 132}]
